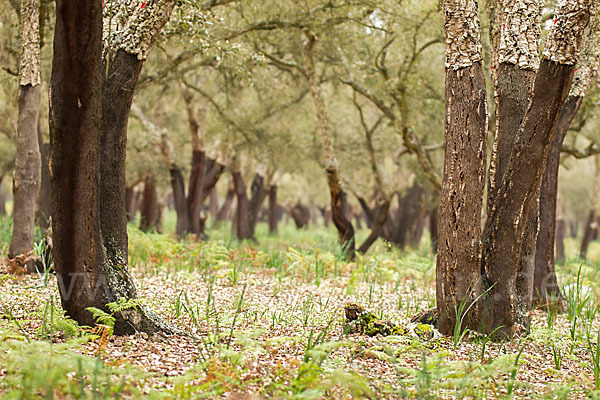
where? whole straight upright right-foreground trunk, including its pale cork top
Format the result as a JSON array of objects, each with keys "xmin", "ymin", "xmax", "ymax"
[{"xmin": 436, "ymin": 0, "xmax": 487, "ymax": 334}]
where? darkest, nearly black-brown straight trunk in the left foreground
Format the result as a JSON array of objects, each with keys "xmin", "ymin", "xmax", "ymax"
[{"xmin": 50, "ymin": 0, "xmax": 168, "ymax": 334}]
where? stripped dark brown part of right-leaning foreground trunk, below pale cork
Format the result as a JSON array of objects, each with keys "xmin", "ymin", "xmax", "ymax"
[{"xmin": 482, "ymin": 59, "xmax": 574, "ymax": 337}]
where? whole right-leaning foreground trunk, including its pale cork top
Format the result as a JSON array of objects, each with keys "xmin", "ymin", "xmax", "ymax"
[{"xmin": 481, "ymin": 0, "xmax": 592, "ymax": 337}]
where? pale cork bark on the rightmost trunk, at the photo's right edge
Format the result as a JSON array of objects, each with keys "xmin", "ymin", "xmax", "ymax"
[{"xmin": 569, "ymin": 10, "xmax": 600, "ymax": 97}]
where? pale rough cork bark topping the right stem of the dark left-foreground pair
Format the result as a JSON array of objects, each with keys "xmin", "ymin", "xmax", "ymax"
[{"xmin": 102, "ymin": 0, "xmax": 175, "ymax": 60}]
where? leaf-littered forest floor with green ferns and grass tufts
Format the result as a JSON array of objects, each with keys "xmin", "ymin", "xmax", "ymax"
[{"xmin": 0, "ymin": 217, "xmax": 600, "ymax": 399}]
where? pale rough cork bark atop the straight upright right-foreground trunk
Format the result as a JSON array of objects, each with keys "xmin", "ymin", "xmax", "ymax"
[{"xmin": 443, "ymin": 0, "xmax": 482, "ymax": 70}]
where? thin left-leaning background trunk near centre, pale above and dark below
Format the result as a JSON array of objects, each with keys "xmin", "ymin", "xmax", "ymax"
[{"xmin": 304, "ymin": 32, "xmax": 355, "ymax": 260}]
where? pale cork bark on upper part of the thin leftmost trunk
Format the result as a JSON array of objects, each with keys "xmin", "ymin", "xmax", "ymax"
[{"xmin": 19, "ymin": 0, "xmax": 40, "ymax": 86}]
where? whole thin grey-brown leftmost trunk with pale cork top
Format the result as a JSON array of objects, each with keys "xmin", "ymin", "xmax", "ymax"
[{"xmin": 8, "ymin": 0, "xmax": 41, "ymax": 258}]
